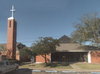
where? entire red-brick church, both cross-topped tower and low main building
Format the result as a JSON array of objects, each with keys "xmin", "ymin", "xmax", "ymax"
[{"xmin": 0, "ymin": 6, "xmax": 100, "ymax": 63}]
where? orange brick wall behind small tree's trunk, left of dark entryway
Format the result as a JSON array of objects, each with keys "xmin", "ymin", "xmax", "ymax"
[{"xmin": 36, "ymin": 54, "xmax": 51, "ymax": 63}]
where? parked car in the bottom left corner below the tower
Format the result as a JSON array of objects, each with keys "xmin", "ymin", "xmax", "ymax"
[{"xmin": 0, "ymin": 60, "xmax": 18, "ymax": 74}]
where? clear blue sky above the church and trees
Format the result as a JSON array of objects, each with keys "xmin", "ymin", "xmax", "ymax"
[{"xmin": 0, "ymin": 0, "xmax": 100, "ymax": 46}]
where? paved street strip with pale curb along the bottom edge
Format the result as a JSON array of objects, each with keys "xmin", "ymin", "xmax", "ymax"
[{"xmin": 6, "ymin": 68, "xmax": 100, "ymax": 74}]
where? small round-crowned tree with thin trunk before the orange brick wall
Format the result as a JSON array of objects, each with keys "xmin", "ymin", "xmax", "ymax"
[{"xmin": 31, "ymin": 37, "xmax": 59, "ymax": 63}]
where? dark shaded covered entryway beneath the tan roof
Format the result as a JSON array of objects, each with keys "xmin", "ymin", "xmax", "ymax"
[{"xmin": 51, "ymin": 52, "xmax": 88, "ymax": 62}]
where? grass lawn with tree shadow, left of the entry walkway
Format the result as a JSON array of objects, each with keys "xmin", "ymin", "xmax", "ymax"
[{"xmin": 19, "ymin": 64, "xmax": 73, "ymax": 70}]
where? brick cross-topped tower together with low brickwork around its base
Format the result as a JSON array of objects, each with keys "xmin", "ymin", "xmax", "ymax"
[{"xmin": 0, "ymin": 6, "xmax": 19, "ymax": 59}]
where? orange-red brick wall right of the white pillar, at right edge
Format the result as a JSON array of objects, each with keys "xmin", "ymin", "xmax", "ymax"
[{"xmin": 91, "ymin": 51, "xmax": 100, "ymax": 63}]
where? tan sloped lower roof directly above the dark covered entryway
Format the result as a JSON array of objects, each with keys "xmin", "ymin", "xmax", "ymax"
[{"xmin": 56, "ymin": 43, "xmax": 99, "ymax": 52}]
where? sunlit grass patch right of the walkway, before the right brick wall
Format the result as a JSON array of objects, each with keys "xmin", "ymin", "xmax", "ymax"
[{"xmin": 76, "ymin": 63, "xmax": 100, "ymax": 70}]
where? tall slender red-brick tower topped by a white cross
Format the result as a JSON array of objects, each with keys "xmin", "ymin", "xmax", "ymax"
[{"xmin": 7, "ymin": 6, "xmax": 17, "ymax": 59}]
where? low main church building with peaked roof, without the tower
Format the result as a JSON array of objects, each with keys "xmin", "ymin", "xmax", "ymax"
[{"xmin": 36, "ymin": 35, "xmax": 100, "ymax": 63}]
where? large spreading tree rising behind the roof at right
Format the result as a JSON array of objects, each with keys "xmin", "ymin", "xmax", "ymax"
[{"xmin": 72, "ymin": 15, "xmax": 100, "ymax": 44}]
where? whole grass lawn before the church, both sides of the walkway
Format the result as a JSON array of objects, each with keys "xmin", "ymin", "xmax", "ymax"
[{"xmin": 19, "ymin": 63, "xmax": 100, "ymax": 71}]
